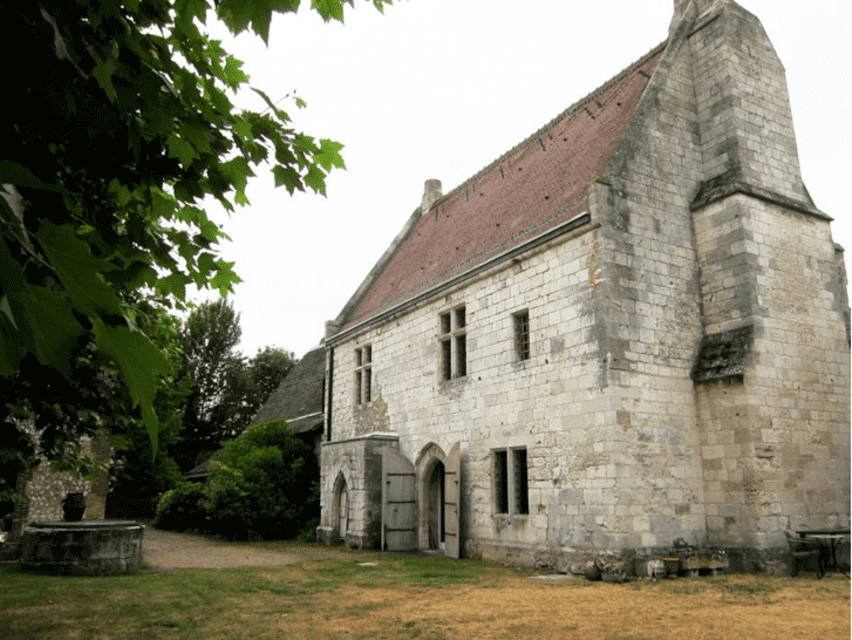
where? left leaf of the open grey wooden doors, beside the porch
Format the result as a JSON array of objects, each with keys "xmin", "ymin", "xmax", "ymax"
[{"xmin": 382, "ymin": 448, "xmax": 417, "ymax": 551}]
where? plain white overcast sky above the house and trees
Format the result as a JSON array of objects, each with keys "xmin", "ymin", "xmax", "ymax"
[{"xmin": 198, "ymin": 0, "xmax": 852, "ymax": 357}]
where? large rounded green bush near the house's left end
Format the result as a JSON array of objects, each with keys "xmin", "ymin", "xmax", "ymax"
[{"xmin": 202, "ymin": 420, "xmax": 319, "ymax": 539}]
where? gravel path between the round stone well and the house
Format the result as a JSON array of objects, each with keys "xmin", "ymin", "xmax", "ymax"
[{"xmin": 142, "ymin": 523, "xmax": 358, "ymax": 571}]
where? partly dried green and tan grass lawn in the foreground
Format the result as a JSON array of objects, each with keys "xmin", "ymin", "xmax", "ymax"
[{"xmin": 0, "ymin": 553, "xmax": 850, "ymax": 640}]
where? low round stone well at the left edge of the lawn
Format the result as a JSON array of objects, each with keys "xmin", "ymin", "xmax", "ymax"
[{"xmin": 21, "ymin": 520, "xmax": 145, "ymax": 576}]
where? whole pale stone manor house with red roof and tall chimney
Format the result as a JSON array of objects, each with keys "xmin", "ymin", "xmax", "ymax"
[{"xmin": 318, "ymin": 0, "xmax": 850, "ymax": 570}]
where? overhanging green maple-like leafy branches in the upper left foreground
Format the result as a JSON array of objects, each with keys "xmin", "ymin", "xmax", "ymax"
[{"xmin": 0, "ymin": 0, "xmax": 390, "ymax": 470}]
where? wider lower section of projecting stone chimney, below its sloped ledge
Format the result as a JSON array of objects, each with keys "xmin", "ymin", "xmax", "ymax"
[{"xmin": 695, "ymin": 195, "xmax": 850, "ymax": 548}]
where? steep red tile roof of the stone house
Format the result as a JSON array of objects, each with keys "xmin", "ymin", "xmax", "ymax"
[{"xmin": 341, "ymin": 43, "xmax": 665, "ymax": 330}]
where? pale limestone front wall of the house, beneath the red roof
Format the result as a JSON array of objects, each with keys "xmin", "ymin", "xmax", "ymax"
[{"xmin": 323, "ymin": 225, "xmax": 604, "ymax": 560}]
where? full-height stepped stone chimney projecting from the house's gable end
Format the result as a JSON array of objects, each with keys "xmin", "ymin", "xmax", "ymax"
[{"xmin": 688, "ymin": 4, "xmax": 850, "ymax": 556}]
